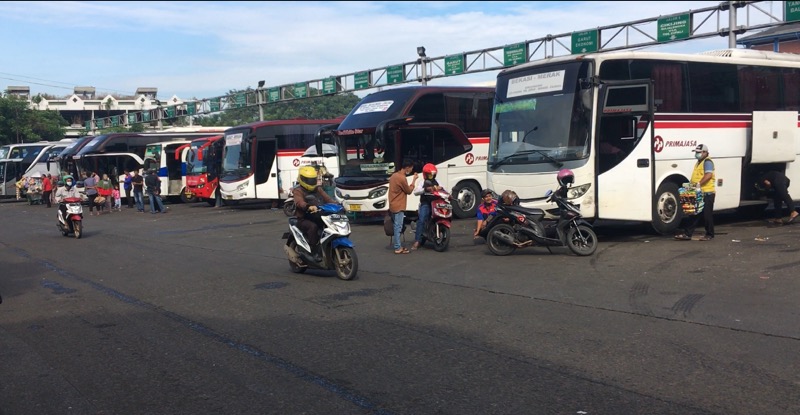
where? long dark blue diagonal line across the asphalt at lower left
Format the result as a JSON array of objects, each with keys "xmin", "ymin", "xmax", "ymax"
[{"xmin": 14, "ymin": 249, "xmax": 393, "ymax": 415}]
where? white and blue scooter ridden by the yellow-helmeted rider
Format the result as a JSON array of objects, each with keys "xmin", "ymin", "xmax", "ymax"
[{"xmin": 283, "ymin": 203, "xmax": 358, "ymax": 280}]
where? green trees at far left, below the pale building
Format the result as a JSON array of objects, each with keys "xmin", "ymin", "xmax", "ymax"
[{"xmin": 0, "ymin": 96, "xmax": 68, "ymax": 144}]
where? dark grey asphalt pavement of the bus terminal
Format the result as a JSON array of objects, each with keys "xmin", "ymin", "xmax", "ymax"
[{"xmin": 0, "ymin": 202, "xmax": 800, "ymax": 415}]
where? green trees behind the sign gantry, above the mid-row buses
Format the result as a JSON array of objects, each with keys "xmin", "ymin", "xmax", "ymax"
[{"xmin": 194, "ymin": 89, "xmax": 361, "ymax": 127}]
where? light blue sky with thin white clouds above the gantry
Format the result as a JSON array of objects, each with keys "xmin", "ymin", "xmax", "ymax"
[{"xmin": 0, "ymin": 1, "xmax": 782, "ymax": 99}]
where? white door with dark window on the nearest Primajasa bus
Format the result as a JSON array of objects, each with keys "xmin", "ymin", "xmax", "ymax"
[{"xmin": 594, "ymin": 80, "xmax": 655, "ymax": 222}]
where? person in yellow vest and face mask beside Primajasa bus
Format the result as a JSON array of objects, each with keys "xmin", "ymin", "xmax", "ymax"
[{"xmin": 675, "ymin": 144, "xmax": 717, "ymax": 241}]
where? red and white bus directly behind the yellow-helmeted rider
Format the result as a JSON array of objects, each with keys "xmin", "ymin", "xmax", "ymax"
[{"xmin": 219, "ymin": 118, "xmax": 342, "ymax": 201}]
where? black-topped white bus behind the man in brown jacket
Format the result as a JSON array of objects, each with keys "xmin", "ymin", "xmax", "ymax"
[{"xmin": 335, "ymin": 86, "xmax": 494, "ymax": 218}]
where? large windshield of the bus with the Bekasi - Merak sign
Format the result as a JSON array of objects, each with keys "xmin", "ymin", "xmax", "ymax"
[{"xmin": 488, "ymin": 61, "xmax": 592, "ymax": 170}]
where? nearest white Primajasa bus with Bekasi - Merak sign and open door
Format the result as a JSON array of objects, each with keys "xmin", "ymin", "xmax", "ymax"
[{"xmin": 487, "ymin": 49, "xmax": 800, "ymax": 234}]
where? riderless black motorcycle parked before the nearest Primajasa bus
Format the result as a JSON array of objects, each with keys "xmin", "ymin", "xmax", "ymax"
[{"xmin": 481, "ymin": 186, "xmax": 597, "ymax": 256}]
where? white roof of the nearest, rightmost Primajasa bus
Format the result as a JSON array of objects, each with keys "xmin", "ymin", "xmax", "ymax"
[{"xmin": 498, "ymin": 49, "xmax": 800, "ymax": 76}]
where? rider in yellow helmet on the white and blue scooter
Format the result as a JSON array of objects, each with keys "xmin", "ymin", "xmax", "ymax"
[{"xmin": 292, "ymin": 166, "xmax": 336, "ymax": 261}]
